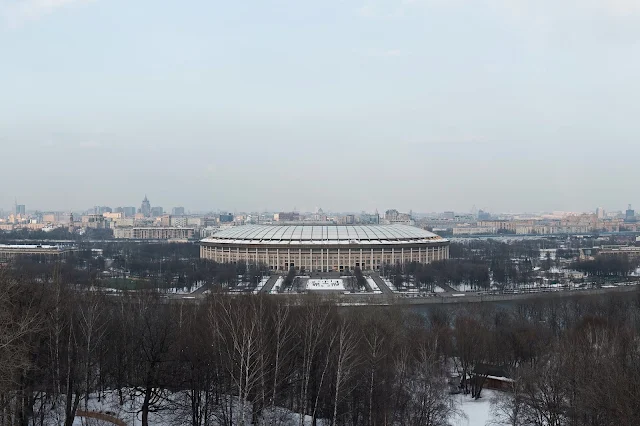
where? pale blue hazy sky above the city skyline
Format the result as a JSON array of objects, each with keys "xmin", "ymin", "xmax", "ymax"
[{"xmin": 0, "ymin": 0, "xmax": 640, "ymax": 211}]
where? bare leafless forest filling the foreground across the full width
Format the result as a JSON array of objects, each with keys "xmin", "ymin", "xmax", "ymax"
[{"xmin": 0, "ymin": 268, "xmax": 640, "ymax": 426}]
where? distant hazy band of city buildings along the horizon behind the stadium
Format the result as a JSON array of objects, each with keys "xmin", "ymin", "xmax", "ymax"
[{"xmin": 0, "ymin": 195, "xmax": 640, "ymax": 241}]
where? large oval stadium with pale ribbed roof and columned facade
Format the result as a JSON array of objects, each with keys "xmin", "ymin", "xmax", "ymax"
[{"xmin": 200, "ymin": 225, "xmax": 449, "ymax": 272}]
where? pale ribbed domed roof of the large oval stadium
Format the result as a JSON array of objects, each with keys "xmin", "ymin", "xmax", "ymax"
[{"xmin": 202, "ymin": 225, "xmax": 446, "ymax": 245}]
